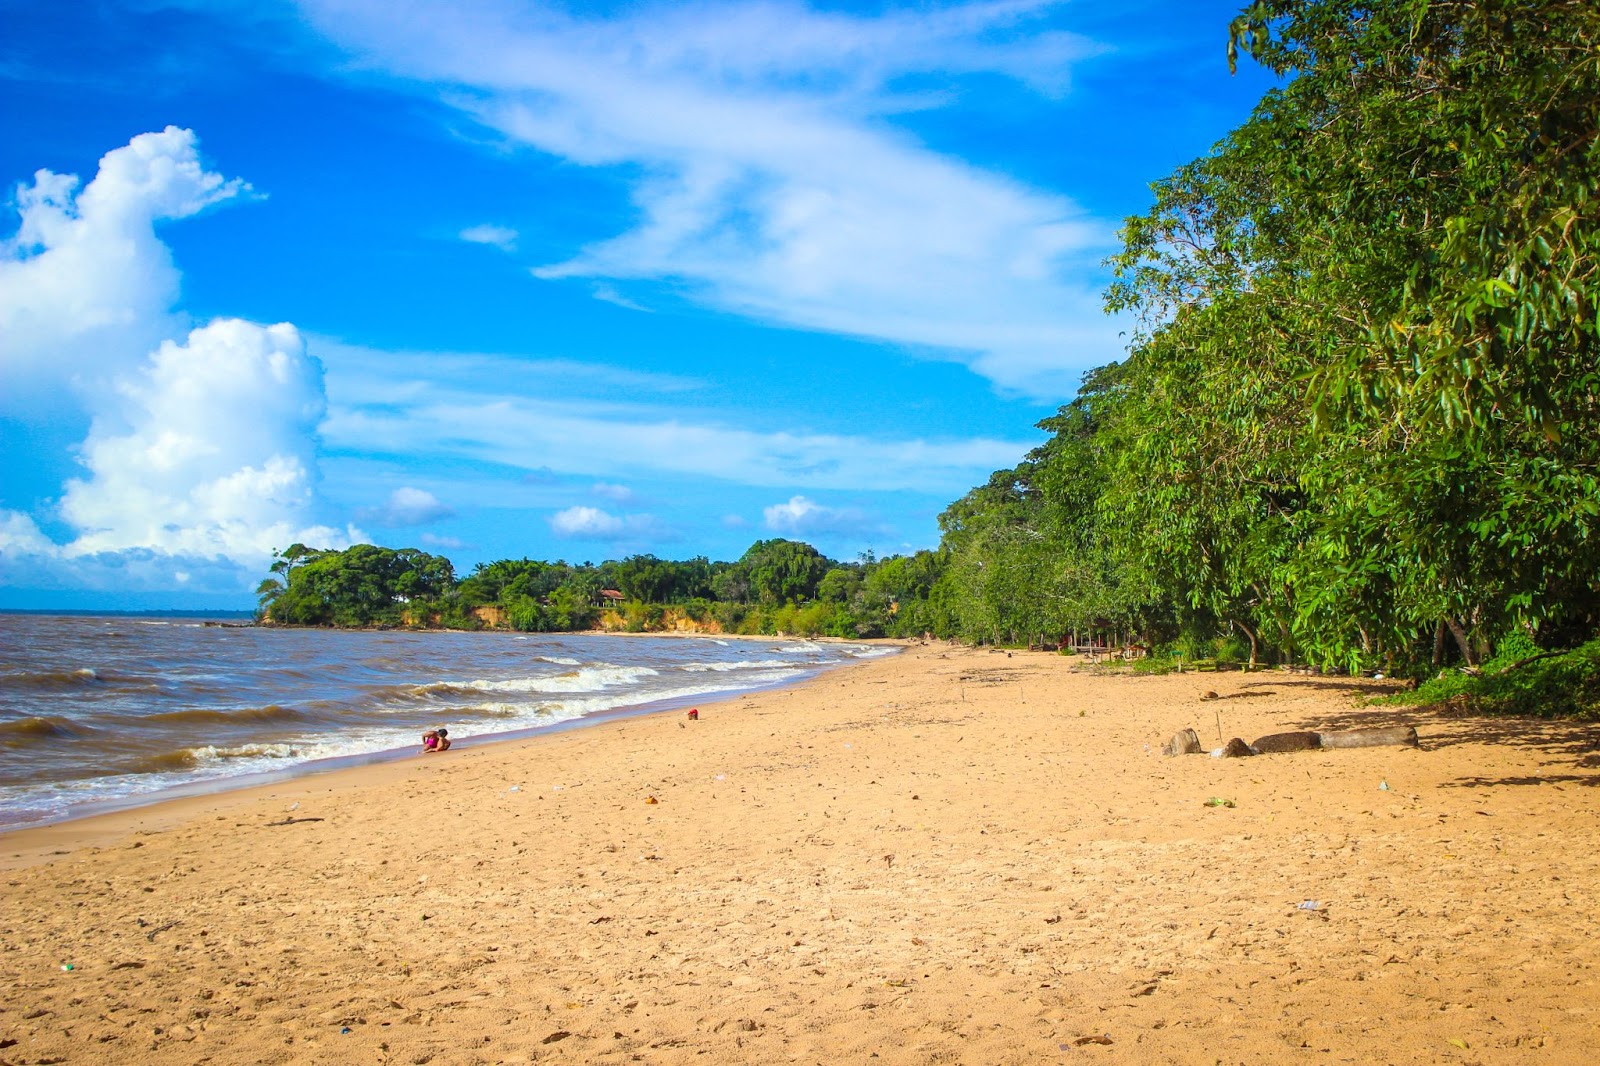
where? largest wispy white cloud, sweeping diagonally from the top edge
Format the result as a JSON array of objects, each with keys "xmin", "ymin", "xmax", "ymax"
[{"xmin": 302, "ymin": 0, "xmax": 1122, "ymax": 397}]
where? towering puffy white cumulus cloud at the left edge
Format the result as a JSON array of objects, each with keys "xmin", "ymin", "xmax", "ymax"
[{"xmin": 0, "ymin": 126, "xmax": 362, "ymax": 591}]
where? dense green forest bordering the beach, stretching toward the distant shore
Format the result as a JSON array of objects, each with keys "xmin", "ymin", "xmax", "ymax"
[{"xmin": 256, "ymin": 0, "xmax": 1600, "ymax": 688}]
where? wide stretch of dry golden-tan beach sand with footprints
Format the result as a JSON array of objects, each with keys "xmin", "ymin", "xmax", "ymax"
[{"xmin": 0, "ymin": 645, "xmax": 1600, "ymax": 1066}]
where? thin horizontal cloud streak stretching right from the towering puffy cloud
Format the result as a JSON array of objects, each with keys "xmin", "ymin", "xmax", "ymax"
[{"xmin": 317, "ymin": 341, "xmax": 1032, "ymax": 499}]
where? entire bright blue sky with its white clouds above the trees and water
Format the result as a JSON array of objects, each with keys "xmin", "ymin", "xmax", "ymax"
[{"xmin": 0, "ymin": 0, "xmax": 1269, "ymax": 607}]
